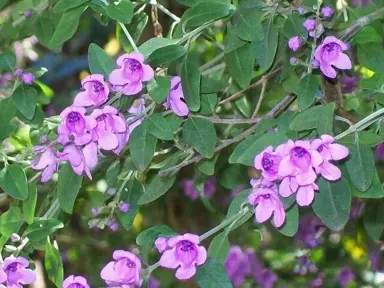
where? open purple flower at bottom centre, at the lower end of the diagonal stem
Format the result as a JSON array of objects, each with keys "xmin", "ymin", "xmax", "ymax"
[{"xmin": 159, "ymin": 233, "xmax": 207, "ymax": 280}]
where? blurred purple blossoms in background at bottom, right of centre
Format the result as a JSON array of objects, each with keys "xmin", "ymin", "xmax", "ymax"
[{"xmin": 224, "ymin": 246, "xmax": 277, "ymax": 288}]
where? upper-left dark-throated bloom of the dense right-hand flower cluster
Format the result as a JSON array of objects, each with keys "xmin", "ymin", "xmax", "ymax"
[{"xmin": 254, "ymin": 145, "xmax": 284, "ymax": 181}]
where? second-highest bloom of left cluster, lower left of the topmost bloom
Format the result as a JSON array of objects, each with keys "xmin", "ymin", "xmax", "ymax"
[{"xmin": 73, "ymin": 74, "xmax": 109, "ymax": 107}]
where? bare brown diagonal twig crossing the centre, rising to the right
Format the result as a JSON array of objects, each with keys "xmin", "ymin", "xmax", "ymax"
[{"xmin": 159, "ymin": 94, "xmax": 296, "ymax": 176}]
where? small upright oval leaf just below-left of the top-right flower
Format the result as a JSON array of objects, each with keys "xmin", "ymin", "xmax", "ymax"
[{"xmin": 297, "ymin": 74, "xmax": 319, "ymax": 110}]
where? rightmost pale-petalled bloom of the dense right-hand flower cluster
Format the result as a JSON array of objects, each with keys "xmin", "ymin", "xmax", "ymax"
[{"xmin": 311, "ymin": 135, "xmax": 349, "ymax": 181}]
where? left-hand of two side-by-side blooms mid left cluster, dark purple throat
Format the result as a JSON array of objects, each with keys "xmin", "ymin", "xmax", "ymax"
[{"xmin": 57, "ymin": 106, "xmax": 97, "ymax": 145}]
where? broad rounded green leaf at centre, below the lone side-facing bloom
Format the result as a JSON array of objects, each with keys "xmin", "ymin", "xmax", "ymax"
[{"xmin": 182, "ymin": 118, "xmax": 216, "ymax": 158}]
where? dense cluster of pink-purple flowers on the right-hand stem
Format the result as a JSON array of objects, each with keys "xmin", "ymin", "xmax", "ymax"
[{"xmin": 248, "ymin": 135, "xmax": 349, "ymax": 227}]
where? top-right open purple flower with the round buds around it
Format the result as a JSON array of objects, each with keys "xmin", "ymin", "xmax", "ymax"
[{"xmin": 288, "ymin": 6, "xmax": 352, "ymax": 78}]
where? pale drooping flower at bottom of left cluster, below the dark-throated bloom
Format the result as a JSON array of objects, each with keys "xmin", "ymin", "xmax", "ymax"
[{"xmin": 57, "ymin": 142, "xmax": 97, "ymax": 180}]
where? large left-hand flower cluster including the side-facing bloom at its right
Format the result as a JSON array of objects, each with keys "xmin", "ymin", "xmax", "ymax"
[{"xmin": 31, "ymin": 52, "xmax": 189, "ymax": 182}]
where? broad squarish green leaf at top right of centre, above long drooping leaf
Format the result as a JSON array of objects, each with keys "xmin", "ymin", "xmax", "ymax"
[{"xmin": 234, "ymin": 9, "xmax": 264, "ymax": 42}]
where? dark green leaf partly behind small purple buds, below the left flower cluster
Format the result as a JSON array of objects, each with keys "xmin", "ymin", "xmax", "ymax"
[{"xmin": 116, "ymin": 178, "xmax": 144, "ymax": 230}]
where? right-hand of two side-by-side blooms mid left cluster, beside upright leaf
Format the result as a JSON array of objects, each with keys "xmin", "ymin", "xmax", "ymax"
[{"xmin": 91, "ymin": 106, "xmax": 127, "ymax": 151}]
